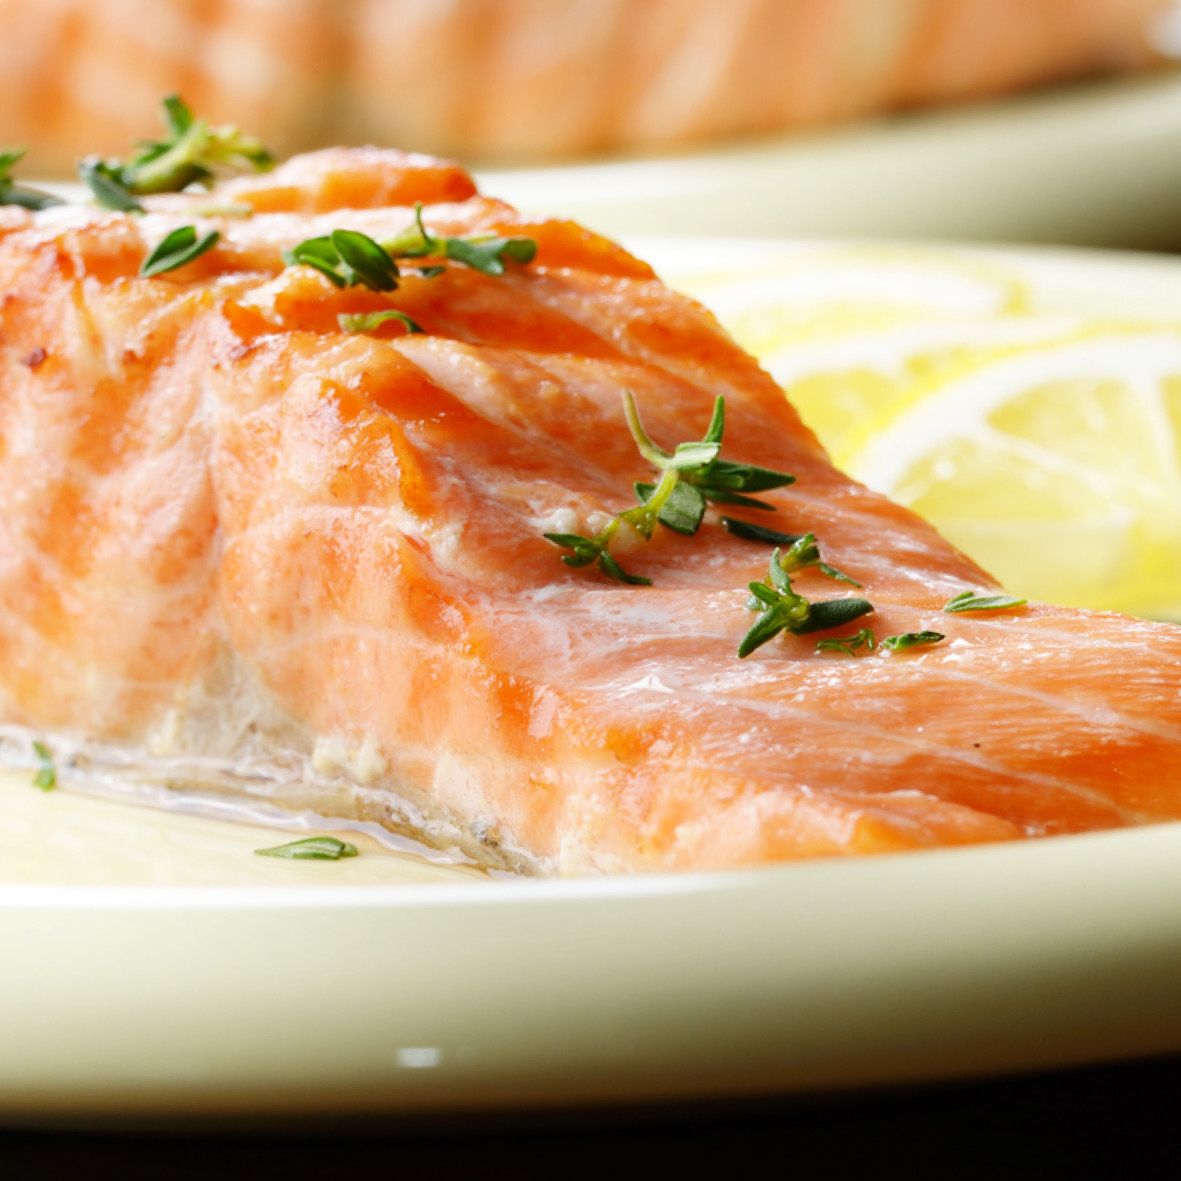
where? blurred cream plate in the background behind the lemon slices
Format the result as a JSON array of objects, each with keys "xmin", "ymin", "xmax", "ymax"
[{"xmin": 481, "ymin": 70, "xmax": 1181, "ymax": 247}]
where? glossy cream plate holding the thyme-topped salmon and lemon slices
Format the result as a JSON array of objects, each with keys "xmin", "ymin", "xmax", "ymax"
[{"xmin": 0, "ymin": 242, "xmax": 1181, "ymax": 1120}]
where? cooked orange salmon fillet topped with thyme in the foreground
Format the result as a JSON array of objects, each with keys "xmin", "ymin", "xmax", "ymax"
[{"xmin": 0, "ymin": 149, "xmax": 1181, "ymax": 874}]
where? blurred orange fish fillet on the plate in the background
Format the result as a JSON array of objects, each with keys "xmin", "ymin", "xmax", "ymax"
[{"xmin": 0, "ymin": 0, "xmax": 1173, "ymax": 176}]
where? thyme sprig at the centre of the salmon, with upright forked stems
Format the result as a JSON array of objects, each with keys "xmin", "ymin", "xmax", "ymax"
[{"xmin": 543, "ymin": 390, "xmax": 793, "ymax": 586}]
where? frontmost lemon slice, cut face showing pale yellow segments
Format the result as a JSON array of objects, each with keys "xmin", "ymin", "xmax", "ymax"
[{"xmin": 841, "ymin": 327, "xmax": 1181, "ymax": 614}]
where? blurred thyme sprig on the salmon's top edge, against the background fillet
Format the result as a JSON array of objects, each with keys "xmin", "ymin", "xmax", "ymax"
[{"xmin": 78, "ymin": 94, "xmax": 274, "ymax": 213}]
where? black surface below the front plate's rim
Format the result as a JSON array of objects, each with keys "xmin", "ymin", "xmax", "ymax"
[{"xmin": 0, "ymin": 1057, "xmax": 1181, "ymax": 1181}]
